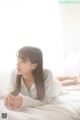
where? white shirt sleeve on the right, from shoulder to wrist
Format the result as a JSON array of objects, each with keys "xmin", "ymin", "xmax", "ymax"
[{"xmin": 21, "ymin": 70, "xmax": 62, "ymax": 107}]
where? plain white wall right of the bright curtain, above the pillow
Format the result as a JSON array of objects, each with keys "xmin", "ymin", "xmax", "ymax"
[{"xmin": 60, "ymin": 4, "xmax": 80, "ymax": 56}]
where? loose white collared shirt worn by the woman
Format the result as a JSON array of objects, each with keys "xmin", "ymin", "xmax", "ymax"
[{"xmin": 9, "ymin": 69, "xmax": 62, "ymax": 108}]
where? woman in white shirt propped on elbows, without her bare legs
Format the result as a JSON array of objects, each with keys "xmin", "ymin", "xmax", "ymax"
[{"xmin": 4, "ymin": 46, "xmax": 62, "ymax": 109}]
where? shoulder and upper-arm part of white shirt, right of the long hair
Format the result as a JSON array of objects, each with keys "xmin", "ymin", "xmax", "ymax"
[{"xmin": 44, "ymin": 70, "xmax": 62, "ymax": 99}]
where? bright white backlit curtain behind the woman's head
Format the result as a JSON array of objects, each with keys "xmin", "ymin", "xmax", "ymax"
[{"xmin": 0, "ymin": 0, "xmax": 63, "ymax": 75}]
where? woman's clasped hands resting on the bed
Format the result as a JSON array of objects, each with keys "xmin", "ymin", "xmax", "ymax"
[{"xmin": 4, "ymin": 94, "xmax": 23, "ymax": 109}]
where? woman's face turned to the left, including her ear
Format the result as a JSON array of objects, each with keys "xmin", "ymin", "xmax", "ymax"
[{"xmin": 17, "ymin": 58, "xmax": 37, "ymax": 75}]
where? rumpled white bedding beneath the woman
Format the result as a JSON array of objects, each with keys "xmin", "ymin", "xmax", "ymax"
[{"xmin": 0, "ymin": 86, "xmax": 80, "ymax": 120}]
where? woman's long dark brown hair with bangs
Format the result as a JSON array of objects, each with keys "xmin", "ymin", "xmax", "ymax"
[{"xmin": 11, "ymin": 46, "xmax": 45, "ymax": 100}]
